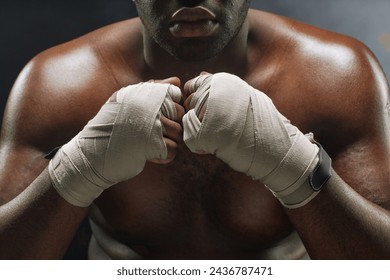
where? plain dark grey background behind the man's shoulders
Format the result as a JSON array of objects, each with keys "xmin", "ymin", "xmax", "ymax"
[{"xmin": 0, "ymin": 0, "xmax": 390, "ymax": 127}]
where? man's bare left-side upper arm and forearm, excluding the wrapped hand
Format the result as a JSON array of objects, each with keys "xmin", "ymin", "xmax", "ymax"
[{"xmin": 0, "ymin": 57, "xmax": 87, "ymax": 259}]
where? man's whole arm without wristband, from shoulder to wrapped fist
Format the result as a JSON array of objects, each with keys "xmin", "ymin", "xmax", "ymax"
[{"xmin": 0, "ymin": 38, "xmax": 184, "ymax": 259}]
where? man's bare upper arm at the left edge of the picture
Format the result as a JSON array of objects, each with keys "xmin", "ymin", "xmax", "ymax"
[{"xmin": 0, "ymin": 57, "xmax": 54, "ymax": 204}]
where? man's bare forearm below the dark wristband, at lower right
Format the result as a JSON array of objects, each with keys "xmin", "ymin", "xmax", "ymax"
[{"xmin": 287, "ymin": 172, "xmax": 390, "ymax": 259}]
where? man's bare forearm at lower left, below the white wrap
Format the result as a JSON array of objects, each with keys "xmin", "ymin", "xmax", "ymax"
[{"xmin": 0, "ymin": 167, "xmax": 87, "ymax": 259}]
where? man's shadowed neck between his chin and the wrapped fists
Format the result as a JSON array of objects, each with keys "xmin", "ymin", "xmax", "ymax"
[{"xmin": 143, "ymin": 20, "xmax": 249, "ymax": 83}]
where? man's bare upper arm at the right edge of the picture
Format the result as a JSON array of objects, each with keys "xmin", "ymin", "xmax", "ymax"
[{"xmin": 318, "ymin": 39, "xmax": 390, "ymax": 209}]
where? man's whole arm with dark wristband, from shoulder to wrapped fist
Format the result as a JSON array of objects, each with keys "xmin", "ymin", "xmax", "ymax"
[{"xmin": 183, "ymin": 36, "xmax": 390, "ymax": 259}]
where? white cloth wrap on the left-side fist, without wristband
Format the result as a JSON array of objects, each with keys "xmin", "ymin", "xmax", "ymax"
[{"xmin": 49, "ymin": 83, "xmax": 181, "ymax": 207}]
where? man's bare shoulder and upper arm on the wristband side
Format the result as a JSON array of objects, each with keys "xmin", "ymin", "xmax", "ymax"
[{"xmin": 247, "ymin": 13, "xmax": 390, "ymax": 205}]
